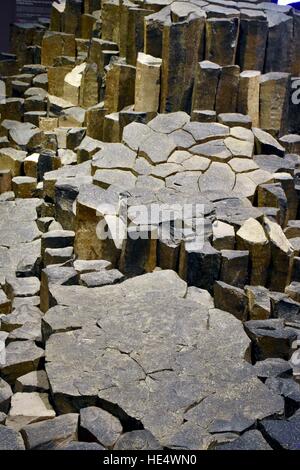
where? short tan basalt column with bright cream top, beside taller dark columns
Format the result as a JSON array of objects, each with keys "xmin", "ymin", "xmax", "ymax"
[{"xmin": 134, "ymin": 52, "xmax": 162, "ymax": 112}]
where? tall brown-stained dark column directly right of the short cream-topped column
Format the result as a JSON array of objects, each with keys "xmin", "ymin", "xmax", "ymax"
[{"xmin": 160, "ymin": 12, "xmax": 205, "ymax": 112}]
